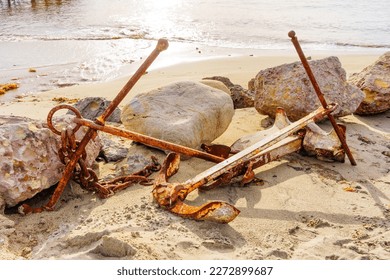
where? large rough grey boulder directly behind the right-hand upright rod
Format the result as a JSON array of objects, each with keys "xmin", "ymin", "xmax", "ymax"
[{"xmin": 255, "ymin": 56, "xmax": 364, "ymax": 121}]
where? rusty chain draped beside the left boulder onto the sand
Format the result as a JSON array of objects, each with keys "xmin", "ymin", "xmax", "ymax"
[{"xmin": 58, "ymin": 128, "xmax": 161, "ymax": 198}]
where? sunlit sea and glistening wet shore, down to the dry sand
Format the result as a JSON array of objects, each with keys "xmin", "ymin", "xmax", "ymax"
[{"xmin": 0, "ymin": 0, "xmax": 390, "ymax": 101}]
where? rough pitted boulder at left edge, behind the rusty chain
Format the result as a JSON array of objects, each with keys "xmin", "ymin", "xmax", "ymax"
[{"xmin": 0, "ymin": 115, "xmax": 100, "ymax": 207}]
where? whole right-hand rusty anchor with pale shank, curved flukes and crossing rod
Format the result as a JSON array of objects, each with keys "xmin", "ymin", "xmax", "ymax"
[{"xmin": 153, "ymin": 31, "xmax": 356, "ymax": 223}]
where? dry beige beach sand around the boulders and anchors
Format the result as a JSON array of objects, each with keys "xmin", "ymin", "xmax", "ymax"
[{"xmin": 0, "ymin": 53, "xmax": 390, "ymax": 260}]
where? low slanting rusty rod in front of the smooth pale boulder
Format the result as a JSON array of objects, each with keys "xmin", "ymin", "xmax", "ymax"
[{"xmin": 73, "ymin": 118, "xmax": 225, "ymax": 163}]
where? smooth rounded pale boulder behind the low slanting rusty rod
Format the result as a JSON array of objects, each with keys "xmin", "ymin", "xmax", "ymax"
[{"xmin": 121, "ymin": 81, "xmax": 234, "ymax": 149}]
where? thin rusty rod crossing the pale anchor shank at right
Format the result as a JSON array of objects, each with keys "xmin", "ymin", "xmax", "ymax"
[{"xmin": 288, "ymin": 31, "xmax": 356, "ymax": 165}]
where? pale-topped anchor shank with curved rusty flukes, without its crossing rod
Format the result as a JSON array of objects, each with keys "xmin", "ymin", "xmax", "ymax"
[{"xmin": 153, "ymin": 104, "xmax": 336, "ymax": 223}]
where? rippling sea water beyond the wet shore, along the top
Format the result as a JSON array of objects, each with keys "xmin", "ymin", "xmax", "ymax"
[{"xmin": 0, "ymin": 0, "xmax": 390, "ymax": 49}]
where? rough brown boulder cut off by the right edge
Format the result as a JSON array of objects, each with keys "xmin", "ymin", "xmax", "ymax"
[{"xmin": 348, "ymin": 52, "xmax": 390, "ymax": 115}]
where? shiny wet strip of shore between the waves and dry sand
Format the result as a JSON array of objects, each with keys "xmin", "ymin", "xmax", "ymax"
[{"xmin": 0, "ymin": 38, "xmax": 390, "ymax": 103}]
